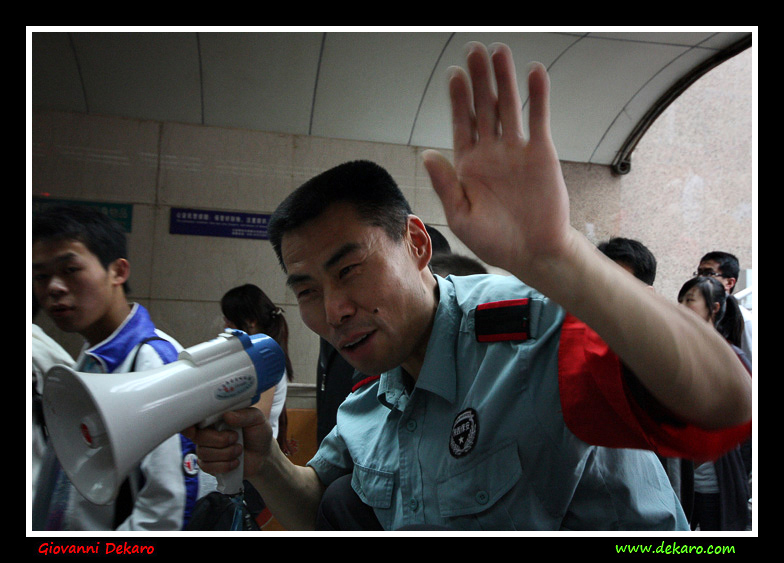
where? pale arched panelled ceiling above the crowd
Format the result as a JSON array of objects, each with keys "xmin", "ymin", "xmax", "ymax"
[{"xmin": 28, "ymin": 28, "xmax": 752, "ymax": 173}]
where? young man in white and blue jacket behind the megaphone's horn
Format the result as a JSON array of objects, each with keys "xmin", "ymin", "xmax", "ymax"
[{"xmin": 32, "ymin": 207, "xmax": 216, "ymax": 531}]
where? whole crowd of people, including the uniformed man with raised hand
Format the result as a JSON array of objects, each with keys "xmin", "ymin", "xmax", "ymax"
[{"xmin": 32, "ymin": 44, "xmax": 752, "ymax": 531}]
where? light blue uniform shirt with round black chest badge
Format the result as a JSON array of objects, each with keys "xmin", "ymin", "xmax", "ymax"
[{"xmin": 308, "ymin": 276, "xmax": 688, "ymax": 530}]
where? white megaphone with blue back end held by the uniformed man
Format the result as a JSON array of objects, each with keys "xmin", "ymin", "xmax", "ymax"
[{"xmin": 43, "ymin": 330, "xmax": 285, "ymax": 504}]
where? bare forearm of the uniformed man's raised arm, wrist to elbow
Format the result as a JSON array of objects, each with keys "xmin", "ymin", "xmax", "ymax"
[{"xmin": 520, "ymin": 231, "xmax": 751, "ymax": 429}]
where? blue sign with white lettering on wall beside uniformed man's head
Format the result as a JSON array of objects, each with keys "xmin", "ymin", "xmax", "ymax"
[{"xmin": 169, "ymin": 207, "xmax": 270, "ymax": 240}]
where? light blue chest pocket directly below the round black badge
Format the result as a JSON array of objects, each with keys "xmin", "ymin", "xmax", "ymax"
[{"xmin": 436, "ymin": 442, "xmax": 523, "ymax": 518}]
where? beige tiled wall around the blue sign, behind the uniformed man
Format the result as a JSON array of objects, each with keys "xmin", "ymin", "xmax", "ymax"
[{"xmin": 32, "ymin": 112, "xmax": 464, "ymax": 407}]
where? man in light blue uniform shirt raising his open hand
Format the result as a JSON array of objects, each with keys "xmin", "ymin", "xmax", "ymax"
[{"xmin": 189, "ymin": 44, "xmax": 751, "ymax": 530}]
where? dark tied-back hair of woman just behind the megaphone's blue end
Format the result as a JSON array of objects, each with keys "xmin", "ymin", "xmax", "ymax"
[{"xmin": 221, "ymin": 283, "xmax": 294, "ymax": 380}]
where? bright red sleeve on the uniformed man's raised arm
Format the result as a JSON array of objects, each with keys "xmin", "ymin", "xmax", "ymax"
[{"xmin": 558, "ymin": 315, "xmax": 751, "ymax": 460}]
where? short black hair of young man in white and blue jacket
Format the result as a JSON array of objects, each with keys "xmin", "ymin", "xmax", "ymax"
[{"xmin": 32, "ymin": 205, "xmax": 130, "ymax": 293}]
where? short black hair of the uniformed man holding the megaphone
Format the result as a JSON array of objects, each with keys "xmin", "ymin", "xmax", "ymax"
[{"xmin": 267, "ymin": 160, "xmax": 411, "ymax": 270}]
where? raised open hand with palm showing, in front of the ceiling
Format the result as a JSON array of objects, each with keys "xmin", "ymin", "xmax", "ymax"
[{"xmin": 423, "ymin": 43, "xmax": 572, "ymax": 281}]
